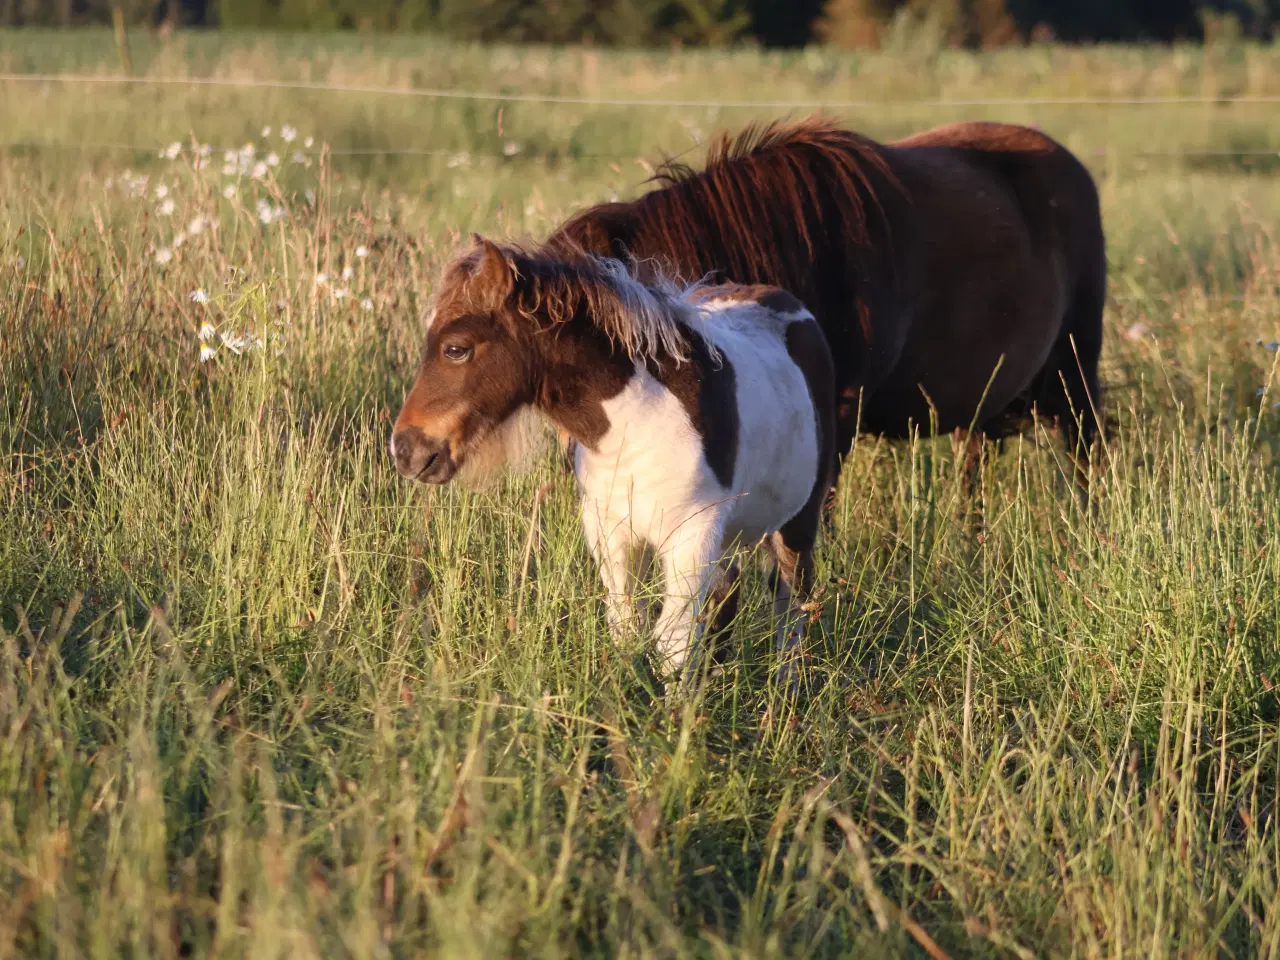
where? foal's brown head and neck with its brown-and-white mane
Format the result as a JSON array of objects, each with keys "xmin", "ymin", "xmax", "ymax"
[{"xmin": 390, "ymin": 234, "xmax": 696, "ymax": 484}]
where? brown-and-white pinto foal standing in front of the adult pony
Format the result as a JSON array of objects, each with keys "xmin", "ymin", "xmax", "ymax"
[{"xmin": 390, "ymin": 237, "xmax": 836, "ymax": 678}]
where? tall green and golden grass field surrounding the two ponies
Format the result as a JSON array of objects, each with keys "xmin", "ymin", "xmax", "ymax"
[{"xmin": 0, "ymin": 32, "xmax": 1280, "ymax": 957}]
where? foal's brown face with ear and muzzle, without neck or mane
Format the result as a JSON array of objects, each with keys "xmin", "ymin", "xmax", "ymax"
[{"xmin": 390, "ymin": 234, "xmax": 535, "ymax": 484}]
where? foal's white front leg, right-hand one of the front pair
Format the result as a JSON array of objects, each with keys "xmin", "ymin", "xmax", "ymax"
[{"xmin": 654, "ymin": 522, "xmax": 723, "ymax": 680}]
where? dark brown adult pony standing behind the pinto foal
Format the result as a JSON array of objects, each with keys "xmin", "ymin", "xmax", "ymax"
[{"xmin": 547, "ymin": 118, "xmax": 1107, "ymax": 478}]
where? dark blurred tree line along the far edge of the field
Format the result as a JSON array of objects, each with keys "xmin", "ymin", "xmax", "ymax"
[{"xmin": 0, "ymin": 0, "xmax": 1280, "ymax": 49}]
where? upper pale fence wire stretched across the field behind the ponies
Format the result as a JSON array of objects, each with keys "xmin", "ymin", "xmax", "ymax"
[{"xmin": 0, "ymin": 73, "xmax": 1280, "ymax": 110}]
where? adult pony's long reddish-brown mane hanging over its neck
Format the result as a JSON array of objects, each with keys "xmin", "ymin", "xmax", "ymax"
[{"xmin": 548, "ymin": 116, "xmax": 897, "ymax": 308}]
